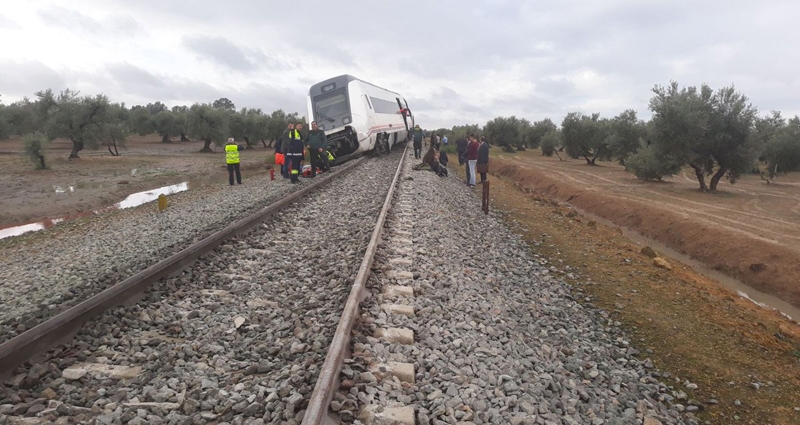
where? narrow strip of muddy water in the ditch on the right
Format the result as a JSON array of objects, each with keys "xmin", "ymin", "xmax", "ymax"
[{"xmin": 580, "ymin": 210, "xmax": 800, "ymax": 323}]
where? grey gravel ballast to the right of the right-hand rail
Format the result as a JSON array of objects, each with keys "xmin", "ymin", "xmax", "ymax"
[{"xmin": 344, "ymin": 154, "xmax": 702, "ymax": 425}]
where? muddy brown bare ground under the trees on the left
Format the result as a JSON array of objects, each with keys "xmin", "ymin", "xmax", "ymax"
[{"xmin": 0, "ymin": 135, "xmax": 273, "ymax": 228}]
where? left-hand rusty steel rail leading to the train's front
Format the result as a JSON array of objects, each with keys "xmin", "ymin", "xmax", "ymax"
[{"xmin": 0, "ymin": 157, "xmax": 365, "ymax": 376}]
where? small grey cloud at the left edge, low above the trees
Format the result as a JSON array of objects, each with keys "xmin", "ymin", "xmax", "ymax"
[{"xmin": 0, "ymin": 61, "xmax": 66, "ymax": 98}]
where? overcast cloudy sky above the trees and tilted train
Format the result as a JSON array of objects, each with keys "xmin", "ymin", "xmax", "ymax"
[{"xmin": 0, "ymin": 0, "xmax": 800, "ymax": 127}]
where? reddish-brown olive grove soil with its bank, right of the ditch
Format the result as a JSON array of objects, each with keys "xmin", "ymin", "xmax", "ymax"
[{"xmin": 492, "ymin": 152, "xmax": 800, "ymax": 307}]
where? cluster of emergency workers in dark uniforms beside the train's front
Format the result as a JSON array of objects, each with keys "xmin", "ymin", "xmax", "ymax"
[{"xmin": 275, "ymin": 121, "xmax": 333, "ymax": 183}]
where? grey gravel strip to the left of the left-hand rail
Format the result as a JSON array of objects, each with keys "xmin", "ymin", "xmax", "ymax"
[{"xmin": 0, "ymin": 166, "xmax": 340, "ymax": 342}]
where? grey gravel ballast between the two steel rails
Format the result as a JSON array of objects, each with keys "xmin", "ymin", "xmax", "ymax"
[{"xmin": 0, "ymin": 153, "xmax": 400, "ymax": 424}]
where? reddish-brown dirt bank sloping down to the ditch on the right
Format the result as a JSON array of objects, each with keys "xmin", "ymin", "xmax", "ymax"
[{"xmin": 492, "ymin": 158, "xmax": 800, "ymax": 307}]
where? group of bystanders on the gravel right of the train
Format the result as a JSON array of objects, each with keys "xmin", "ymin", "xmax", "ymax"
[{"xmin": 411, "ymin": 125, "xmax": 489, "ymax": 186}]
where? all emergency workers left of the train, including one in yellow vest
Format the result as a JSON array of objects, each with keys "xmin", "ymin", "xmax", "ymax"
[{"xmin": 225, "ymin": 121, "xmax": 334, "ymax": 186}]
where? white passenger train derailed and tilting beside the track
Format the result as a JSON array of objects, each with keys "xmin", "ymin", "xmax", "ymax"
[{"xmin": 308, "ymin": 75, "xmax": 414, "ymax": 162}]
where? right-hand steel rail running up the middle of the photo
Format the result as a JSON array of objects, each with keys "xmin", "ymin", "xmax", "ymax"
[{"xmin": 302, "ymin": 145, "xmax": 408, "ymax": 425}]
